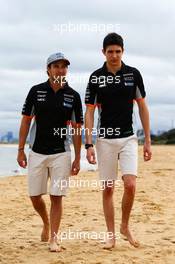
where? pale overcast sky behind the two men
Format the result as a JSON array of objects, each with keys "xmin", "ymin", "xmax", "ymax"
[{"xmin": 0, "ymin": 0, "xmax": 175, "ymax": 136}]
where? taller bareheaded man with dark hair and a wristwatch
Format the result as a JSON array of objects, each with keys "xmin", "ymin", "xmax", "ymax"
[{"xmin": 85, "ymin": 33, "xmax": 151, "ymax": 248}]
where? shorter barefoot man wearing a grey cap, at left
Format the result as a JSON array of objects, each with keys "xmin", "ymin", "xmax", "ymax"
[{"xmin": 17, "ymin": 52, "xmax": 83, "ymax": 251}]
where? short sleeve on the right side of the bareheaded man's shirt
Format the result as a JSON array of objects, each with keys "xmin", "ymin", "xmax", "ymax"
[{"xmin": 134, "ymin": 70, "xmax": 146, "ymax": 100}]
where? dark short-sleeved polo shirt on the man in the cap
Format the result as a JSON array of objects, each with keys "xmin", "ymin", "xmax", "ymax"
[{"xmin": 22, "ymin": 80, "xmax": 83, "ymax": 154}]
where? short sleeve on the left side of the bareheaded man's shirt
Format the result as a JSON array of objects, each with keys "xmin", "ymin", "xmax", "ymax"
[{"xmin": 85, "ymin": 74, "xmax": 97, "ymax": 106}]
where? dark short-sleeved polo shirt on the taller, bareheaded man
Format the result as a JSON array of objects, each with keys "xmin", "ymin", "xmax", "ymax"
[{"xmin": 85, "ymin": 62, "xmax": 146, "ymax": 138}]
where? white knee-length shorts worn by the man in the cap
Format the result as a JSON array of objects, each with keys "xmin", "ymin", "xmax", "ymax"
[{"xmin": 27, "ymin": 150, "xmax": 71, "ymax": 196}]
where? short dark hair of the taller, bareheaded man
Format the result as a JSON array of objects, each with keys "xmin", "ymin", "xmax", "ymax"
[{"xmin": 103, "ymin": 32, "xmax": 124, "ymax": 51}]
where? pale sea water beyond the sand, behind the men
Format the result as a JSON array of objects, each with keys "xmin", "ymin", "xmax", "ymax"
[{"xmin": 0, "ymin": 144, "xmax": 97, "ymax": 177}]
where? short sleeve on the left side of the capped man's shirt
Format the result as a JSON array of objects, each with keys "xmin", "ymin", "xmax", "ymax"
[{"xmin": 22, "ymin": 88, "xmax": 35, "ymax": 117}]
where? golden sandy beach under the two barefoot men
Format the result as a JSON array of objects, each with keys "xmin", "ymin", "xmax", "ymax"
[{"xmin": 0, "ymin": 146, "xmax": 175, "ymax": 264}]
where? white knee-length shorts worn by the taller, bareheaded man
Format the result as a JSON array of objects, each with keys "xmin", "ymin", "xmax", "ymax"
[{"xmin": 96, "ymin": 134, "xmax": 138, "ymax": 181}]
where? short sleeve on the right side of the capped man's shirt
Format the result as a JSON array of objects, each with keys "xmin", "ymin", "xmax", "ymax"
[{"xmin": 71, "ymin": 93, "xmax": 83, "ymax": 125}]
